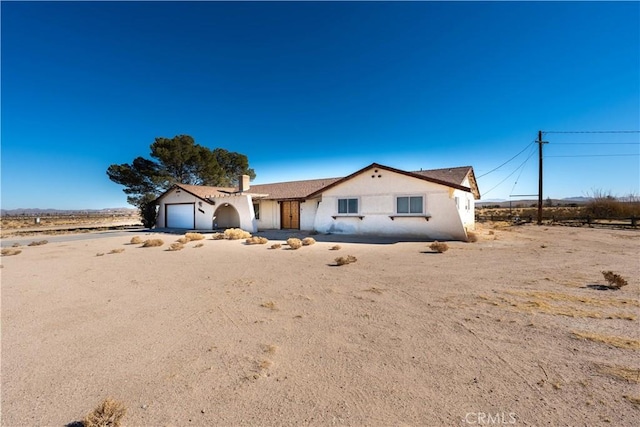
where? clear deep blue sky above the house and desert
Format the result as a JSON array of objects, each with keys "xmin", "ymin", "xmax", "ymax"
[{"xmin": 1, "ymin": 1, "xmax": 640, "ymax": 209}]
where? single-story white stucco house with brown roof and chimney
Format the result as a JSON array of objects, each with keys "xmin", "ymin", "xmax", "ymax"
[{"xmin": 156, "ymin": 163, "xmax": 480, "ymax": 240}]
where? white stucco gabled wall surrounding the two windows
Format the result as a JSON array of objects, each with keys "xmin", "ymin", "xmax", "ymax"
[{"xmin": 314, "ymin": 168, "xmax": 466, "ymax": 240}]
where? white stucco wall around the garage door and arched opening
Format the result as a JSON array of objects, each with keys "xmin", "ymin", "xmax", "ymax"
[{"xmin": 156, "ymin": 188, "xmax": 257, "ymax": 232}]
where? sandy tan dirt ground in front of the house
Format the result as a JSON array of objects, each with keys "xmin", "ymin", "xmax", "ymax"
[{"xmin": 0, "ymin": 225, "xmax": 640, "ymax": 426}]
